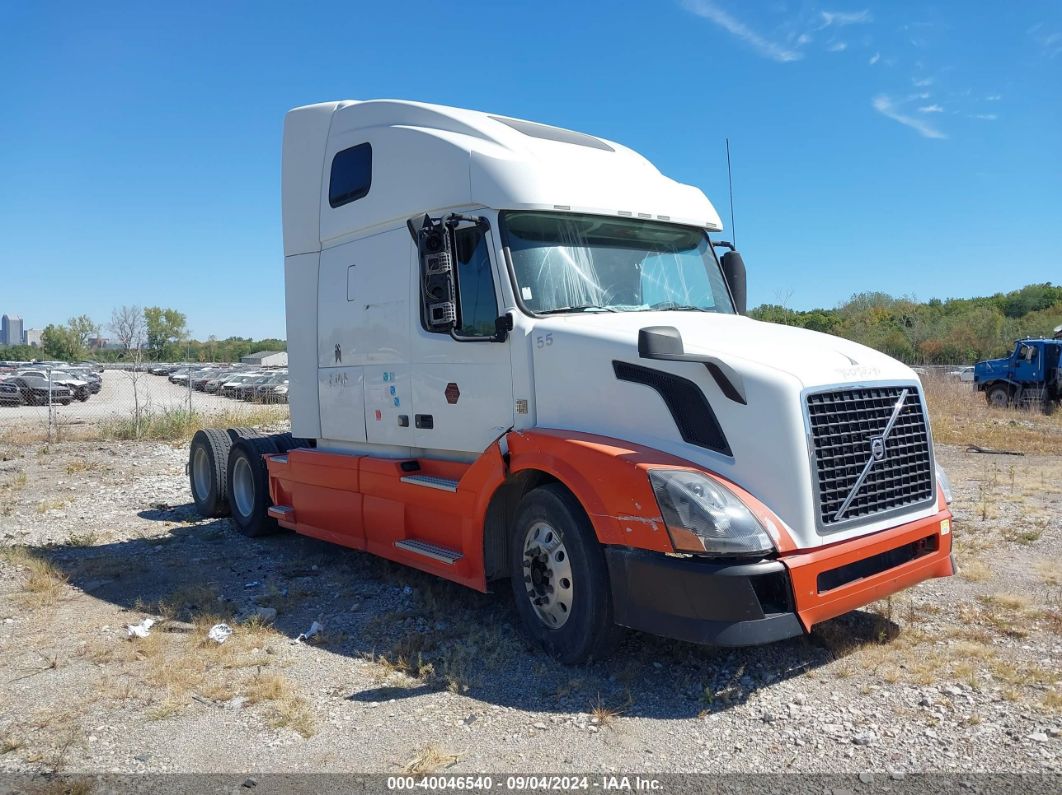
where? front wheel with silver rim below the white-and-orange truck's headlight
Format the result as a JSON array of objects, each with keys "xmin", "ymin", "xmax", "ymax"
[{"xmin": 509, "ymin": 484, "xmax": 620, "ymax": 664}]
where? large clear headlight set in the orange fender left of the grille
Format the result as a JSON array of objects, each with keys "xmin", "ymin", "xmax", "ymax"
[{"xmin": 649, "ymin": 469, "xmax": 774, "ymax": 556}]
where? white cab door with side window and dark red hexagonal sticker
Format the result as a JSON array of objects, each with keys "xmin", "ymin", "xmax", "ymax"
[{"xmin": 412, "ymin": 225, "xmax": 514, "ymax": 457}]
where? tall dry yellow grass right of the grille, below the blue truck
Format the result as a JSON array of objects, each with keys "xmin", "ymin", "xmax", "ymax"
[{"xmin": 923, "ymin": 376, "xmax": 1062, "ymax": 454}]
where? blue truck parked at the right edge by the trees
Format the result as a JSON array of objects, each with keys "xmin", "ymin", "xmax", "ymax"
[{"xmin": 974, "ymin": 327, "xmax": 1062, "ymax": 414}]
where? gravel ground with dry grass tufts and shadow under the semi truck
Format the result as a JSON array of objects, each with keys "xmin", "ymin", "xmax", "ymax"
[{"xmin": 0, "ymin": 442, "xmax": 1062, "ymax": 778}]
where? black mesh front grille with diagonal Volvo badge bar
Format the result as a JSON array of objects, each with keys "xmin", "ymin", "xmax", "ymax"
[{"xmin": 807, "ymin": 386, "xmax": 933, "ymax": 529}]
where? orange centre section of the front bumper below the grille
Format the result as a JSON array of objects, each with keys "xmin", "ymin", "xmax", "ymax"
[{"xmin": 781, "ymin": 508, "xmax": 955, "ymax": 632}]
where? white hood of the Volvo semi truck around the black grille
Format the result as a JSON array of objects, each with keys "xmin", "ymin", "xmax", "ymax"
[{"xmin": 528, "ymin": 311, "xmax": 933, "ymax": 549}]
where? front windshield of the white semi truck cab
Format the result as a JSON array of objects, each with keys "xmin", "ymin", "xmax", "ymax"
[{"xmin": 501, "ymin": 211, "xmax": 734, "ymax": 314}]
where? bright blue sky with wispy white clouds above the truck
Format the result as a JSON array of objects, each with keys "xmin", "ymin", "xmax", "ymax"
[{"xmin": 0, "ymin": 0, "xmax": 1062, "ymax": 339}]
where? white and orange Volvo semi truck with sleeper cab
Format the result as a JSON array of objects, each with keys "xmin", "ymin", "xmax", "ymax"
[{"xmin": 188, "ymin": 100, "xmax": 955, "ymax": 663}]
